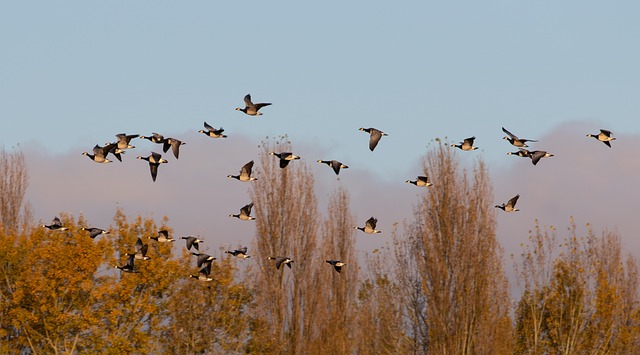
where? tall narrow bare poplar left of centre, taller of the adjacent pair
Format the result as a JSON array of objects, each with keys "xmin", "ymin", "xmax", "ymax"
[{"xmin": 249, "ymin": 139, "xmax": 326, "ymax": 353}]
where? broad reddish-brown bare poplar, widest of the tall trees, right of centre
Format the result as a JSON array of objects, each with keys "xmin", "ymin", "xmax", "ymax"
[{"xmin": 394, "ymin": 140, "xmax": 511, "ymax": 354}]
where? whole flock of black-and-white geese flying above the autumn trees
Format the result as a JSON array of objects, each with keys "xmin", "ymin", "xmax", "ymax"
[{"xmin": 50, "ymin": 94, "xmax": 615, "ymax": 281}]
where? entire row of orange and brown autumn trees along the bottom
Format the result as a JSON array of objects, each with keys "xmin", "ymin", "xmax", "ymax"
[{"xmin": 0, "ymin": 140, "xmax": 640, "ymax": 354}]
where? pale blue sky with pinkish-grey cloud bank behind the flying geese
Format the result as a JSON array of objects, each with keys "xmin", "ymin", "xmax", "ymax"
[{"xmin": 0, "ymin": 1, "xmax": 640, "ymax": 284}]
